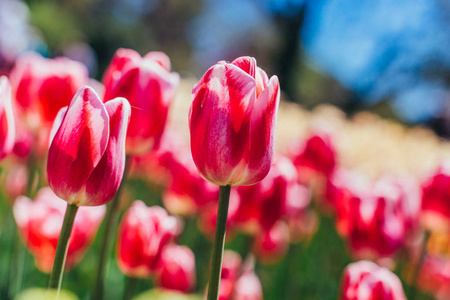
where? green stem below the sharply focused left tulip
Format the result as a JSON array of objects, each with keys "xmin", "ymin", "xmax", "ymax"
[{"xmin": 48, "ymin": 204, "xmax": 78, "ymax": 294}]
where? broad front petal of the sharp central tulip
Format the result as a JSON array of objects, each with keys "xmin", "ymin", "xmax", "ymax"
[{"xmin": 189, "ymin": 64, "xmax": 256, "ymax": 185}]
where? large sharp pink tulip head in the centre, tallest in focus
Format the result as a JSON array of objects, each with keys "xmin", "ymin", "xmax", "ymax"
[{"xmin": 189, "ymin": 57, "xmax": 280, "ymax": 186}]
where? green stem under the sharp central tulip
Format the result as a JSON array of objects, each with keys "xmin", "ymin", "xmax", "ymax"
[{"xmin": 208, "ymin": 185, "xmax": 231, "ymax": 300}]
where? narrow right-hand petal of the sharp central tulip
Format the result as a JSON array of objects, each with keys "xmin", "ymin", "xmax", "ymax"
[{"xmin": 234, "ymin": 76, "xmax": 280, "ymax": 186}]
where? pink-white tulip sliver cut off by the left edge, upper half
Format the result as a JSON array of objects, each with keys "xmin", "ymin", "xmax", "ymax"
[{"xmin": 0, "ymin": 76, "xmax": 15, "ymax": 159}]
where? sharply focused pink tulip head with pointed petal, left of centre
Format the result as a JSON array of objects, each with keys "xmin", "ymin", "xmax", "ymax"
[{"xmin": 47, "ymin": 86, "xmax": 130, "ymax": 206}]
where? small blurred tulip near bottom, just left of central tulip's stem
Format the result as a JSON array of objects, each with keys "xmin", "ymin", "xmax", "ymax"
[{"xmin": 157, "ymin": 244, "xmax": 196, "ymax": 293}]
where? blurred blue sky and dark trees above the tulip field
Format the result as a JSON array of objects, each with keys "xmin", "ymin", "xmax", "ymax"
[{"xmin": 0, "ymin": 0, "xmax": 450, "ymax": 127}]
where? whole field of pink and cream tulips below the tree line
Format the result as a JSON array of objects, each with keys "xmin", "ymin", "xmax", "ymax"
[{"xmin": 0, "ymin": 48, "xmax": 450, "ymax": 300}]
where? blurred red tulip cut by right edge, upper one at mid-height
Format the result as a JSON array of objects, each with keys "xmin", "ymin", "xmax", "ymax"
[{"xmin": 421, "ymin": 163, "xmax": 450, "ymax": 231}]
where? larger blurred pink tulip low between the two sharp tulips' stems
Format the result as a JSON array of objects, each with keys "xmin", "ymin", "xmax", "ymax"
[{"xmin": 117, "ymin": 200, "xmax": 180, "ymax": 278}]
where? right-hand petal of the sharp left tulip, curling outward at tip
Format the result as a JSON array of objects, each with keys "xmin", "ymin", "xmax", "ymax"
[{"xmin": 80, "ymin": 98, "xmax": 131, "ymax": 206}]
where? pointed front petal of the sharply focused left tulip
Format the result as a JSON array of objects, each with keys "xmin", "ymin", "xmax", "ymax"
[{"xmin": 47, "ymin": 86, "xmax": 109, "ymax": 204}]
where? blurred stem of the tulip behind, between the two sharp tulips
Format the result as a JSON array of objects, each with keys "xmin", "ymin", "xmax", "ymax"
[{"xmin": 92, "ymin": 156, "xmax": 131, "ymax": 300}]
